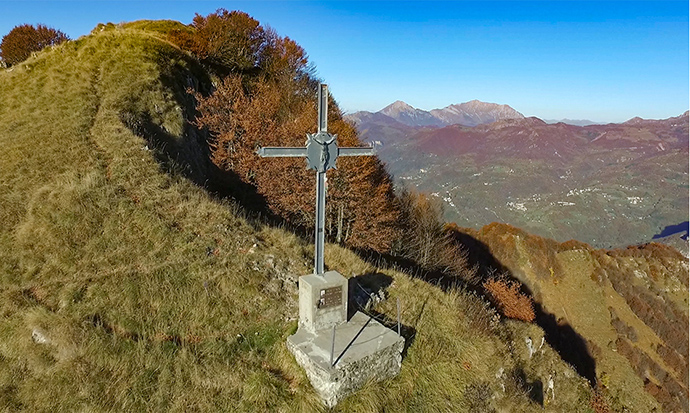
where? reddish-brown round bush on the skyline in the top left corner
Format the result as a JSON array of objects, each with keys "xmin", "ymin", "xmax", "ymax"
[{"xmin": 0, "ymin": 24, "xmax": 69, "ymax": 66}]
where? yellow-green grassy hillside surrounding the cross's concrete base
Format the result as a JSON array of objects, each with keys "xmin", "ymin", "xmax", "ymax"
[{"xmin": 0, "ymin": 22, "xmax": 592, "ymax": 412}]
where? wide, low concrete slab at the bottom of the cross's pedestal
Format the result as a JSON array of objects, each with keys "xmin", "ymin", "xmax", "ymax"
[{"xmin": 287, "ymin": 312, "xmax": 405, "ymax": 407}]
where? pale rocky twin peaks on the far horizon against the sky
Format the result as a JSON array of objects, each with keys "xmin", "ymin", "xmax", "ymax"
[{"xmin": 345, "ymin": 100, "xmax": 525, "ymax": 127}]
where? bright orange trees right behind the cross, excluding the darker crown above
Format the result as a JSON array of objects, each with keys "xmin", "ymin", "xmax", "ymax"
[{"xmin": 197, "ymin": 75, "xmax": 398, "ymax": 252}]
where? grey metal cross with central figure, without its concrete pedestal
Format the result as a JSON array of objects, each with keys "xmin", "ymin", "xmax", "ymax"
[{"xmin": 257, "ymin": 84, "xmax": 376, "ymax": 274}]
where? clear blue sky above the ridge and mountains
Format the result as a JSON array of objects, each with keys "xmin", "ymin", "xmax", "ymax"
[{"xmin": 0, "ymin": 0, "xmax": 690, "ymax": 122}]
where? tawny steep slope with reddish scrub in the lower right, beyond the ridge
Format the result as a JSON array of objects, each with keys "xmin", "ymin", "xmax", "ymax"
[{"xmin": 452, "ymin": 224, "xmax": 688, "ymax": 412}]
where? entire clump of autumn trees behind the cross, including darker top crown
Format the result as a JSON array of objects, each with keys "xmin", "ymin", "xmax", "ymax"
[{"xmin": 177, "ymin": 9, "xmax": 398, "ymax": 252}]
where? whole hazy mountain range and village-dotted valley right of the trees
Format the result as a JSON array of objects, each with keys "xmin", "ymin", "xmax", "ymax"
[{"xmin": 348, "ymin": 101, "xmax": 688, "ymax": 248}]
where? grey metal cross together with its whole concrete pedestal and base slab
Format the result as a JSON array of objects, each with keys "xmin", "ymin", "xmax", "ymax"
[{"xmin": 270, "ymin": 84, "xmax": 405, "ymax": 407}]
